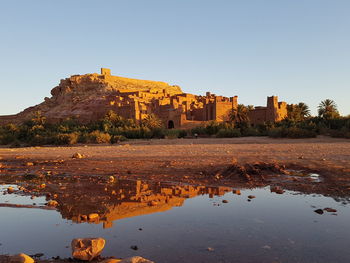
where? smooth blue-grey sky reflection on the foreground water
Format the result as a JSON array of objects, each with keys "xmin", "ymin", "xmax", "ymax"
[{"xmin": 0, "ymin": 188, "xmax": 350, "ymax": 262}]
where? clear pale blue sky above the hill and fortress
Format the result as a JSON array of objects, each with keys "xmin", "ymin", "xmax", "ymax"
[{"xmin": 0, "ymin": 0, "xmax": 350, "ymax": 115}]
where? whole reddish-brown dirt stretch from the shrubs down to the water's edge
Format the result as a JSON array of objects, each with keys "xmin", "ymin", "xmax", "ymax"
[{"xmin": 0, "ymin": 137, "xmax": 350, "ymax": 262}]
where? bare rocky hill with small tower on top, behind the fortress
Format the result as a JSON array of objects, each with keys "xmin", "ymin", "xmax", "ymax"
[{"xmin": 0, "ymin": 69, "xmax": 182, "ymax": 124}]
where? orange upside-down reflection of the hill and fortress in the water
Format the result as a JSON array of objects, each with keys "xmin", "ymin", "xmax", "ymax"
[{"xmin": 59, "ymin": 180, "xmax": 232, "ymax": 230}]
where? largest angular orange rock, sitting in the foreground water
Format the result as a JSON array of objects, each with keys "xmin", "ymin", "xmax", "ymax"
[{"xmin": 71, "ymin": 238, "xmax": 106, "ymax": 261}]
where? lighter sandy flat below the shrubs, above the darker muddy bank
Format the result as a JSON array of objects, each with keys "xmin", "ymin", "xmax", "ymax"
[{"xmin": 0, "ymin": 137, "xmax": 350, "ymax": 179}]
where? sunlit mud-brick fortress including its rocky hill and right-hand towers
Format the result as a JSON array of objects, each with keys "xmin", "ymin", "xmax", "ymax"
[{"xmin": 0, "ymin": 68, "xmax": 287, "ymax": 128}]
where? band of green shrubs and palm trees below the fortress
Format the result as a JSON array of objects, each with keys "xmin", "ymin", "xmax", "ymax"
[{"xmin": 0, "ymin": 99, "xmax": 350, "ymax": 147}]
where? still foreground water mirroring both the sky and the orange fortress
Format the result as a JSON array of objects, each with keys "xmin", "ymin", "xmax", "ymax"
[{"xmin": 0, "ymin": 180, "xmax": 350, "ymax": 263}]
